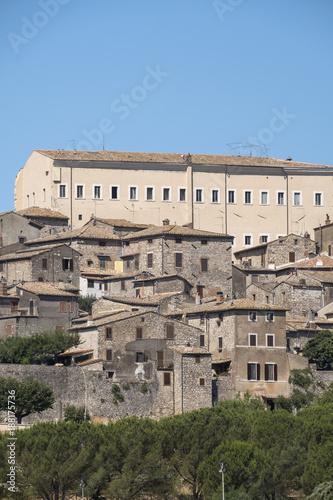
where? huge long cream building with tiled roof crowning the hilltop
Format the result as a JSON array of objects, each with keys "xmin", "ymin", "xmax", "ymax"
[{"xmin": 15, "ymin": 150, "xmax": 333, "ymax": 250}]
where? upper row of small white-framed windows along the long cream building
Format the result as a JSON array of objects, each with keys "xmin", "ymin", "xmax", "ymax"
[{"xmin": 58, "ymin": 184, "xmax": 324, "ymax": 206}]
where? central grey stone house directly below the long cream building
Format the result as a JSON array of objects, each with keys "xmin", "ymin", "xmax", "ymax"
[{"xmin": 121, "ymin": 221, "xmax": 233, "ymax": 297}]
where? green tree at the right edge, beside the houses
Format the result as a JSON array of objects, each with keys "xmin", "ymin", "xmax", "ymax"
[{"xmin": 303, "ymin": 330, "xmax": 333, "ymax": 370}]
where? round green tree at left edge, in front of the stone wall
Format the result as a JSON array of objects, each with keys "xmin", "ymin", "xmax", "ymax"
[{"xmin": 0, "ymin": 377, "xmax": 54, "ymax": 424}]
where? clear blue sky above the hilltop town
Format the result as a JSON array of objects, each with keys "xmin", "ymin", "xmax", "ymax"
[{"xmin": 0, "ymin": 0, "xmax": 333, "ymax": 212}]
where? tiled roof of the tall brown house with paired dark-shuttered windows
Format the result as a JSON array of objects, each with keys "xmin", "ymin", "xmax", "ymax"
[{"xmin": 169, "ymin": 299, "xmax": 287, "ymax": 316}]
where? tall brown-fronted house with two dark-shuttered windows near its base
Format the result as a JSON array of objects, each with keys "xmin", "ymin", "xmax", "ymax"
[{"xmin": 169, "ymin": 296, "xmax": 305, "ymax": 401}]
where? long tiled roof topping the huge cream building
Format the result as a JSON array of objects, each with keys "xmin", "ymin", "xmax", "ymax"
[{"xmin": 35, "ymin": 149, "xmax": 332, "ymax": 169}]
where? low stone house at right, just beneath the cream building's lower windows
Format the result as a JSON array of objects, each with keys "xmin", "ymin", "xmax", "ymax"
[{"xmin": 234, "ymin": 234, "xmax": 316, "ymax": 269}]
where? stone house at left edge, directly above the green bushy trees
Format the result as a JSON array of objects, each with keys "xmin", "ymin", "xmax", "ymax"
[{"xmin": 0, "ymin": 282, "xmax": 78, "ymax": 338}]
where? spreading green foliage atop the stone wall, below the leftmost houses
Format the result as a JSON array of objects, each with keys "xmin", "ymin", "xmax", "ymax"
[{"xmin": 0, "ymin": 331, "xmax": 80, "ymax": 364}]
